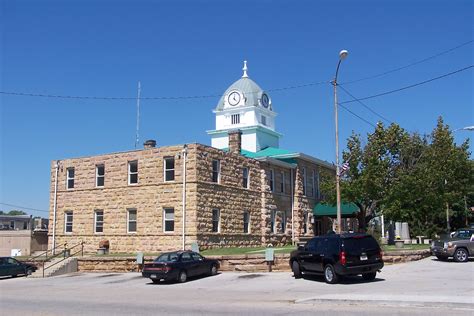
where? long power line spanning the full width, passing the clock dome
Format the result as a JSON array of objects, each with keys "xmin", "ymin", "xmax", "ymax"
[{"xmin": 0, "ymin": 40, "xmax": 474, "ymax": 100}]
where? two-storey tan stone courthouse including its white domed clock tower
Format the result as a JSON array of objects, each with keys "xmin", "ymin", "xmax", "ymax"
[{"xmin": 49, "ymin": 64, "xmax": 335, "ymax": 253}]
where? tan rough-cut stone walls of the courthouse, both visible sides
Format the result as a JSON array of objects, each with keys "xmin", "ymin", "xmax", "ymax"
[{"xmin": 49, "ymin": 144, "xmax": 334, "ymax": 253}]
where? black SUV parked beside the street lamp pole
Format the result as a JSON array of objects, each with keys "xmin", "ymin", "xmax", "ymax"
[{"xmin": 290, "ymin": 233, "xmax": 383, "ymax": 284}]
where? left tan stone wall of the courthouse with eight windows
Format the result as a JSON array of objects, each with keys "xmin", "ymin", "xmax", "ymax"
[{"xmin": 49, "ymin": 145, "xmax": 197, "ymax": 252}]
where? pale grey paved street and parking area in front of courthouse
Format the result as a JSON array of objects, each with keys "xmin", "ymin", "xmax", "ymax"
[{"xmin": 0, "ymin": 257, "xmax": 474, "ymax": 315}]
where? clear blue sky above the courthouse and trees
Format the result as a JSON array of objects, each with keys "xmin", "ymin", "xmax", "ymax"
[{"xmin": 0, "ymin": 0, "xmax": 474, "ymax": 216}]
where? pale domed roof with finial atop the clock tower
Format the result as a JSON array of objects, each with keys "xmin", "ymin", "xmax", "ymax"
[{"xmin": 216, "ymin": 61, "xmax": 271, "ymax": 111}]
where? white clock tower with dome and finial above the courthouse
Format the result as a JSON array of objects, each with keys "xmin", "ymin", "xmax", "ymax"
[{"xmin": 207, "ymin": 61, "xmax": 282, "ymax": 152}]
